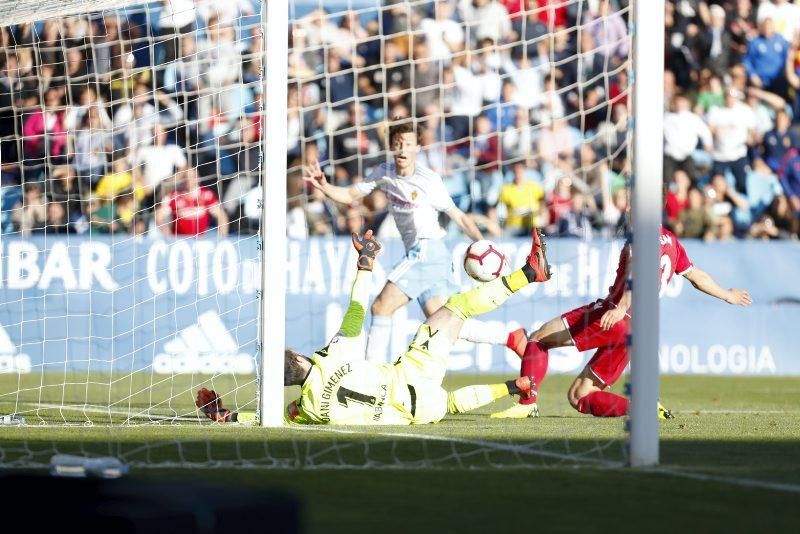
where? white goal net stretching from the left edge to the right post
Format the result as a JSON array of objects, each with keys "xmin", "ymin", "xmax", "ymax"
[{"xmin": 0, "ymin": 0, "xmax": 648, "ymax": 467}]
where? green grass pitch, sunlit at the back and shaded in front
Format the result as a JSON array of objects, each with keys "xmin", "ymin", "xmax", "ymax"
[{"xmin": 0, "ymin": 377, "xmax": 800, "ymax": 532}]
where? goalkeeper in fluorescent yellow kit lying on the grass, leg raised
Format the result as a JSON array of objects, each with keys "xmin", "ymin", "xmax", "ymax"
[{"xmin": 276, "ymin": 230, "xmax": 550, "ymax": 425}]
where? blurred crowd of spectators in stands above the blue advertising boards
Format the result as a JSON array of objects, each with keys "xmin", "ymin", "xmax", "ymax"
[{"xmin": 0, "ymin": 0, "xmax": 800, "ymax": 240}]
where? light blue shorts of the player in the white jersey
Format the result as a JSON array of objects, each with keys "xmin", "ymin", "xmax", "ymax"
[{"xmin": 387, "ymin": 239, "xmax": 459, "ymax": 307}]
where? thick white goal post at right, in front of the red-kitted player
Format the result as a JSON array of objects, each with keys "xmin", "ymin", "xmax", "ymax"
[{"xmin": 629, "ymin": 0, "xmax": 664, "ymax": 467}]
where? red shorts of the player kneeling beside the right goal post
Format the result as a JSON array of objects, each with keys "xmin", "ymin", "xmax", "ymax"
[{"xmin": 561, "ymin": 300, "xmax": 630, "ymax": 386}]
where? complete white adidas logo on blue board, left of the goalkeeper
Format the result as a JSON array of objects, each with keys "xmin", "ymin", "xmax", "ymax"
[{"xmin": 153, "ymin": 310, "xmax": 255, "ymax": 375}]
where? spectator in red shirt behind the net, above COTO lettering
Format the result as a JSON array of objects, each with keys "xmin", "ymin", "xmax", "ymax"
[{"xmin": 156, "ymin": 169, "xmax": 228, "ymax": 236}]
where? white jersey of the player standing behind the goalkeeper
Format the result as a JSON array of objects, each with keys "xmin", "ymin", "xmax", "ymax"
[{"xmin": 356, "ymin": 163, "xmax": 455, "ymax": 250}]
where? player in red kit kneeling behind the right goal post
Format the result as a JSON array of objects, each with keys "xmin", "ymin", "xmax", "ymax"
[{"xmin": 492, "ymin": 227, "xmax": 752, "ymax": 419}]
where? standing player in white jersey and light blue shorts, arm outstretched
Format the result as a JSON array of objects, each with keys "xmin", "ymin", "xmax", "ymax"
[{"xmin": 305, "ymin": 122, "xmax": 508, "ymax": 362}]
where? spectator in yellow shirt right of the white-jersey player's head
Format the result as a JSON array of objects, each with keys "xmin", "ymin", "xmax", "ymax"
[{"xmin": 499, "ymin": 161, "xmax": 548, "ymax": 236}]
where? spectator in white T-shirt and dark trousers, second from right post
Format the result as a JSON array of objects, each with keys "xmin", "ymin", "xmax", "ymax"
[{"xmin": 708, "ymin": 88, "xmax": 757, "ymax": 194}]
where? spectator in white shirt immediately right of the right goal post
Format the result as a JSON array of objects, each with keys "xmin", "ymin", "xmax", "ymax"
[{"xmin": 664, "ymin": 96, "xmax": 714, "ymax": 180}]
